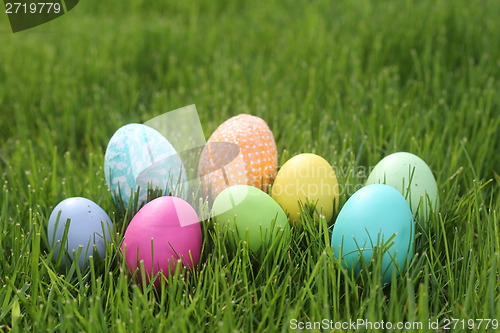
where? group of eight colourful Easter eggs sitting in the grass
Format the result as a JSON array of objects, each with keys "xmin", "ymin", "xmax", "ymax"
[{"xmin": 48, "ymin": 115, "xmax": 439, "ymax": 282}]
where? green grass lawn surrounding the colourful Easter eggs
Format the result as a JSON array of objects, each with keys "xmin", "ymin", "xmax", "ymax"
[{"xmin": 0, "ymin": 0, "xmax": 500, "ymax": 332}]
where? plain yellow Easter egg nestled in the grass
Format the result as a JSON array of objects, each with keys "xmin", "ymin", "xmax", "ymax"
[{"xmin": 271, "ymin": 154, "xmax": 339, "ymax": 225}]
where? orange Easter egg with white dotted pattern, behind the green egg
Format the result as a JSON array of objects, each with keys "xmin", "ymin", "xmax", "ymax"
[{"xmin": 198, "ymin": 114, "xmax": 278, "ymax": 198}]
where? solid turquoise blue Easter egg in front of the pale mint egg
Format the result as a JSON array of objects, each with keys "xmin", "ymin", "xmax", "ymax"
[{"xmin": 332, "ymin": 184, "xmax": 414, "ymax": 283}]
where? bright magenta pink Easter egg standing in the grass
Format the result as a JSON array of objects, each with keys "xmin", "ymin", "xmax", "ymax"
[{"xmin": 122, "ymin": 196, "xmax": 202, "ymax": 286}]
